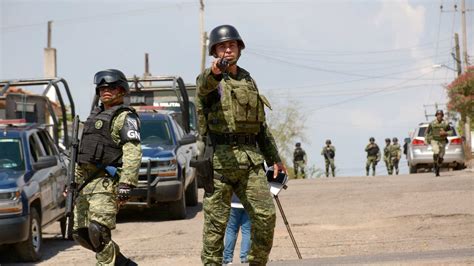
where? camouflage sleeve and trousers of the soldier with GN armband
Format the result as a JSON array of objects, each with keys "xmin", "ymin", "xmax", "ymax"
[{"xmin": 74, "ymin": 111, "xmax": 142, "ymax": 265}]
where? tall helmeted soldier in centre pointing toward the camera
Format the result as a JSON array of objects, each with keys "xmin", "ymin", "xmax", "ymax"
[{"xmin": 196, "ymin": 25, "xmax": 286, "ymax": 265}]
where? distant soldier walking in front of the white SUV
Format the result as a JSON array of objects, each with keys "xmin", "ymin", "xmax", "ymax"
[{"xmin": 426, "ymin": 110, "xmax": 453, "ymax": 176}]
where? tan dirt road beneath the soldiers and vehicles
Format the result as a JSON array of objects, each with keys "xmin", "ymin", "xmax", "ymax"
[{"xmin": 1, "ymin": 171, "xmax": 474, "ymax": 265}]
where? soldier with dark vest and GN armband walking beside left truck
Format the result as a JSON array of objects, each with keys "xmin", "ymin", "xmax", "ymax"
[{"xmin": 73, "ymin": 69, "xmax": 142, "ymax": 265}]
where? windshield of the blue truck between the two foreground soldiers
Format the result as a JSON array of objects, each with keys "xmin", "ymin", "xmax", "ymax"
[{"xmin": 140, "ymin": 120, "xmax": 173, "ymax": 145}]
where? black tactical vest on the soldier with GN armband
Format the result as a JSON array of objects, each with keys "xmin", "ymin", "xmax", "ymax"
[{"xmin": 77, "ymin": 105, "xmax": 135, "ymax": 166}]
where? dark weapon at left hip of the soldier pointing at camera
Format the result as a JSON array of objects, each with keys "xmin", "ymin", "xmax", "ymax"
[{"xmin": 190, "ymin": 133, "xmax": 214, "ymax": 196}]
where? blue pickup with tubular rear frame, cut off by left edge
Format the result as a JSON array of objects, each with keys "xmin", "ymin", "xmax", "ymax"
[{"xmin": 0, "ymin": 79, "xmax": 74, "ymax": 261}]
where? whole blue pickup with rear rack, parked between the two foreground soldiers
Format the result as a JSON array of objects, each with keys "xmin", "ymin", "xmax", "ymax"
[{"xmin": 122, "ymin": 76, "xmax": 198, "ymax": 219}]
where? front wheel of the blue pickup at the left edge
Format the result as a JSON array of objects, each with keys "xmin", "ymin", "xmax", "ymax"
[{"xmin": 15, "ymin": 208, "xmax": 43, "ymax": 261}]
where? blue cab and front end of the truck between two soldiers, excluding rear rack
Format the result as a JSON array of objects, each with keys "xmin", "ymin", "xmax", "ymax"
[{"xmin": 127, "ymin": 112, "xmax": 198, "ymax": 219}]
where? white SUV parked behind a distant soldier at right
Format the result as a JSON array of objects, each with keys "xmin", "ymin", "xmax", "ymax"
[{"xmin": 407, "ymin": 123, "xmax": 465, "ymax": 173}]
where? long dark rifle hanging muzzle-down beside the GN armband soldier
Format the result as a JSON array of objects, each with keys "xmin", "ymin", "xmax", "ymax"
[{"xmin": 65, "ymin": 115, "xmax": 79, "ymax": 239}]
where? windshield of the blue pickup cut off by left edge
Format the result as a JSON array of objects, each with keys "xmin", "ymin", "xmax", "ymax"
[{"xmin": 0, "ymin": 138, "xmax": 25, "ymax": 171}]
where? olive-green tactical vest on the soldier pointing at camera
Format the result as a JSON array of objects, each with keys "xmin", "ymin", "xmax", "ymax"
[{"xmin": 201, "ymin": 73, "xmax": 270, "ymax": 134}]
